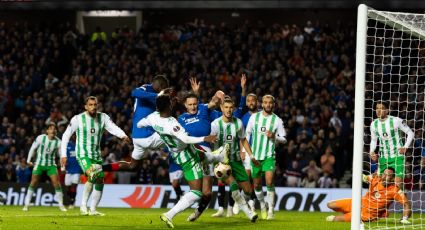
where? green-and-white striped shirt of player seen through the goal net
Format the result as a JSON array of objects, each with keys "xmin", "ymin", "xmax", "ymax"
[{"xmin": 370, "ymin": 116, "xmax": 414, "ymax": 158}]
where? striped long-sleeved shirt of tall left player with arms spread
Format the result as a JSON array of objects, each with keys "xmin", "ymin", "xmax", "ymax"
[{"xmin": 61, "ymin": 112, "xmax": 126, "ymax": 161}]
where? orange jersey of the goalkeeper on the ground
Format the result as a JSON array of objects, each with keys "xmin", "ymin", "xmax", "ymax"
[{"xmin": 362, "ymin": 176, "xmax": 408, "ymax": 220}]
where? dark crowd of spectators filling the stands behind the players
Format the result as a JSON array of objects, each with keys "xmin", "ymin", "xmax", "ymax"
[{"xmin": 0, "ymin": 20, "xmax": 362, "ymax": 188}]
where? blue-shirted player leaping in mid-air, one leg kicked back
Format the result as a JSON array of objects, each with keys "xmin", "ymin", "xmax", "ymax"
[{"xmin": 102, "ymin": 75, "xmax": 168, "ymax": 171}]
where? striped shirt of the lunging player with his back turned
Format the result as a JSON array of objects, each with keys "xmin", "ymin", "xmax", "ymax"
[{"xmin": 137, "ymin": 112, "xmax": 204, "ymax": 165}]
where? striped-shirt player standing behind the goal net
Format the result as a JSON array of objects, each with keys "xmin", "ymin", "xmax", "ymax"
[{"xmin": 369, "ymin": 102, "xmax": 414, "ymax": 186}]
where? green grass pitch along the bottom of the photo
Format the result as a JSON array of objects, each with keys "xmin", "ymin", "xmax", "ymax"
[{"xmin": 0, "ymin": 206, "xmax": 421, "ymax": 230}]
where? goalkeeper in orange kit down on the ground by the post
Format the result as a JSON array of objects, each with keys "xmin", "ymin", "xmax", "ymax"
[{"xmin": 326, "ymin": 168, "xmax": 412, "ymax": 224}]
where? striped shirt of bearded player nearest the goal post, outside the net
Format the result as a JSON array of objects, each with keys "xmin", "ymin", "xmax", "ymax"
[{"xmin": 246, "ymin": 111, "xmax": 286, "ymax": 160}]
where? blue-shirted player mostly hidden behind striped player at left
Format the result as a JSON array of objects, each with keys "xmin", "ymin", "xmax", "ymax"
[{"xmin": 65, "ymin": 138, "xmax": 83, "ymax": 209}]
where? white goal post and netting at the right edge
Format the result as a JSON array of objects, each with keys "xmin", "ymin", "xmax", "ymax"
[{"xmin": 351, "ymin": 5, "xmax": 425, "ymax": 229}]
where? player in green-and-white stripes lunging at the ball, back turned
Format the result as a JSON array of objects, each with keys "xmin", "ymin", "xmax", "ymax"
[{"xmin": 137, "ymin": 92, "xmax": 216, "ymax": 228}]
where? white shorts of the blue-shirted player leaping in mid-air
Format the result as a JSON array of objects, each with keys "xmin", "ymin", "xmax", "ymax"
[{"xmin": 131, "ymin": 133, "xmax": 164, "ymax": 160}]
